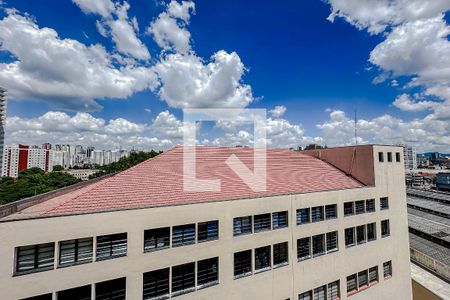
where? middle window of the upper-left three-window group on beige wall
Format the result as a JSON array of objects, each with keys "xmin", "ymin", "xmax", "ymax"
[{"xmin": 59, "ymin": 238, "xmax": 93, "ymax": 266}]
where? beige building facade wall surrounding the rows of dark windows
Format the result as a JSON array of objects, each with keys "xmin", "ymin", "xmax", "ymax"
[{"xmin": 0, "ymin": 146, "xmax": 411, "ymax": 300}]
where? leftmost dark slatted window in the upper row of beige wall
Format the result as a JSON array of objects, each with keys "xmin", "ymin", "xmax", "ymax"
[{"xmin": 16, "ymin": 243, "xmax": 55, "ymax": 273}]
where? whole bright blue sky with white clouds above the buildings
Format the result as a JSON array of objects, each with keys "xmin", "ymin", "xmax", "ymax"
[{"xmin": 0, "ymin": 0, "xmax": 450, "ymax": 152}]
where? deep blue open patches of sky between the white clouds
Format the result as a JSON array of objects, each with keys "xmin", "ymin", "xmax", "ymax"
[{"xmin": 0, "ymin": 0, "xmax": 450, "ymax": 150}]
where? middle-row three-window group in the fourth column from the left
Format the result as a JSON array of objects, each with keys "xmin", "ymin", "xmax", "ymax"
[{"xmin": 297, "ymin": 231, "xmax": 338, "ymax": 260}]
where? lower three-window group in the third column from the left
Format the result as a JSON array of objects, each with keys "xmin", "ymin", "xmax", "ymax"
[{"xmin": 234, "ymin": 242, "xmax": 289, "ymax": 278}]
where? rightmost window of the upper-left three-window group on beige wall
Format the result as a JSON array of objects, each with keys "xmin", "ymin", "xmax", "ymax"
[{"xmin": 97, "ymin": 233, "xmax": 127, "ymax": 260}]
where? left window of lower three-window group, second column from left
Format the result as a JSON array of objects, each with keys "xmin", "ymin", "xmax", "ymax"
[{"xmin": 143, "ymin": 268, "xmax": 170, "ymax": 300}]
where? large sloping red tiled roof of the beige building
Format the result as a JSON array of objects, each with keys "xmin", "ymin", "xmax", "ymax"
[{"xmin": 3, "ymin": 146, "xmax": 364, "ymax": 219}]
